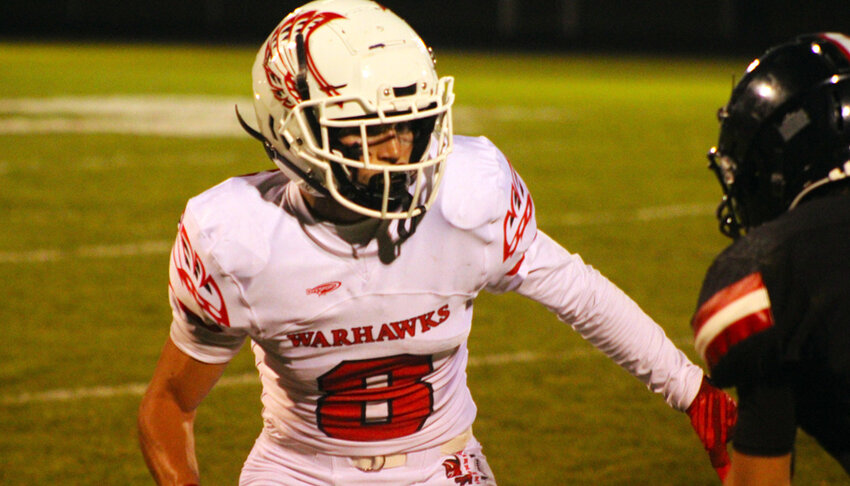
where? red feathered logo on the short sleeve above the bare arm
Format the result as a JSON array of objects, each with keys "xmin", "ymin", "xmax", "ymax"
[{"xmin": 171, "ymin": 224, "xmax": 230, "ymax": 327}]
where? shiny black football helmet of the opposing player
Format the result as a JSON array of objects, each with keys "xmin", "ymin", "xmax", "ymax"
[{"xmin": 708, "ymin": 33, "xmax": 850, "ymax": 238}]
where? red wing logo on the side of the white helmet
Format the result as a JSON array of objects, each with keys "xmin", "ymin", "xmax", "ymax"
[{"xmin": 263, "ymin": 10, "xmax": 345, "ymax": 108}]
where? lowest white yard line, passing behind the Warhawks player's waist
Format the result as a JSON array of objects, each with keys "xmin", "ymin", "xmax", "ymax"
[{"xmin": 0, "ymin": 338, "xmax": 691, "ymax": 406}]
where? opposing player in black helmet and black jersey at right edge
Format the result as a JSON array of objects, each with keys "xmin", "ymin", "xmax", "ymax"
[{"xmin": 692, "ymin": 33, "xmax": 850, "ymax": 486}]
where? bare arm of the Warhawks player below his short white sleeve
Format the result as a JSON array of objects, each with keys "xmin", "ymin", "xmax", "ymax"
[{"xmin": 138, "ymin": 340, "xmax": 225, "ymax": 485}]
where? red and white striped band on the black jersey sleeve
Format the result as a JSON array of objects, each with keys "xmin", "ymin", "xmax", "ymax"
[{"xmin": 691, "ymin": 272, "xmax": 773, "ymax": 367}]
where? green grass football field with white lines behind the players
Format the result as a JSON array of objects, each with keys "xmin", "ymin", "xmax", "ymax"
[{"xmin": 0, "ymin": 43, "xmax": 847, "ymax": 486}]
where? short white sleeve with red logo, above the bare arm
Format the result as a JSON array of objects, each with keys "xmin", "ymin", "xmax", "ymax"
[{"xmin": 168, "ymin": 207, "xmax": 250, "ymax": 363}]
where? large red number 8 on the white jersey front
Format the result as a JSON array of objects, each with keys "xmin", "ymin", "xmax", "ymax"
[{"xmin": 316, "ymin": 354, "xmax": 434, "ymax": 441}]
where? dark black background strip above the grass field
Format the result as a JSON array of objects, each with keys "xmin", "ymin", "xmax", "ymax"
[{"xmin": 0, "ymin": 0, "xmax": 850, "ymax": 54}]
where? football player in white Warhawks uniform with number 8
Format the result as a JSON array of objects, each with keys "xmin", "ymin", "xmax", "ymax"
[{"xmin": 139, "ymin": 0, "xmax": 735, "ymax": 485}]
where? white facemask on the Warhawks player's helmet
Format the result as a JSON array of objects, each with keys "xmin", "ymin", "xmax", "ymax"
[{"xmin": 281, "ymin": 86, "xmax": 453, "ymax": 219}]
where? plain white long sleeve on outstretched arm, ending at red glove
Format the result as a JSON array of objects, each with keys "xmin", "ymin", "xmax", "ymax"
[{"xmin": 516, "ymin": 231, "xmax": 703, "ymax": 411}]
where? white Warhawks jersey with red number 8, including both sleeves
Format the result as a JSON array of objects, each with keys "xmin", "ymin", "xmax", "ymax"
[{"xmin": 169, "ymin": 136, "xmax": 702, "ymax": 456}]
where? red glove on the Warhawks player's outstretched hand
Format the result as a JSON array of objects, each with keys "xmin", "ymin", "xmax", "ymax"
[{"xmin": 687, "ymin": 377, "xmax": 738, "ymax": 481}]
